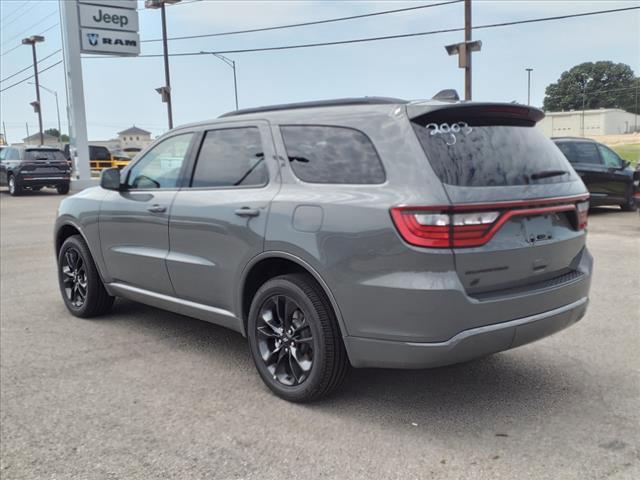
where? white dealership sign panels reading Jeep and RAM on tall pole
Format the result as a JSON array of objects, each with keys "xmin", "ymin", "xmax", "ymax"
[{"xmin": 78, "ymin": 0, "xmax": 140, "ymax": 56}]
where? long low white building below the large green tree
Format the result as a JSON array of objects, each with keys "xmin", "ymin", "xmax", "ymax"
[{"xmin": 538, "ymin": 108, "xmax": 640, "ymax": 137}]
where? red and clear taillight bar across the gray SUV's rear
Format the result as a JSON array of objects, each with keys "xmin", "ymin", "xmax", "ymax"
[{"xmin": 391, "ymin": 196, "xmax": 589, "ymax": 248}]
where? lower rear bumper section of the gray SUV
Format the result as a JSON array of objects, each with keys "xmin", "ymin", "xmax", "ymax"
[{"xmin": 344, "ymin": 297, "xmax": 588, "ymax": 369}]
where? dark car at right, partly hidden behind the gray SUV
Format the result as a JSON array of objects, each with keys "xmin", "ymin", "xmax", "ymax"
[{"xmin": 552, "ymin": 137, "xmax": 640, "ymax": 211}]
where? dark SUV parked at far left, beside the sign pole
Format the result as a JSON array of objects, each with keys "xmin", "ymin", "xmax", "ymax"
[{"xmin": 0, "ymin": 146, "xmax": 71, "ymax": 195}]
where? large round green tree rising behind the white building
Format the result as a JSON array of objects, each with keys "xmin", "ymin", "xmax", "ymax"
[{"xmin": 543, "ymin": 61, "xmax": 640, "ymax": 113}]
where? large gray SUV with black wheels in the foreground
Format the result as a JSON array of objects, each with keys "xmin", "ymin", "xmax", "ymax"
[{"xmin": 55, "ymin": 97, "xmax": 592, "ymax": 401}]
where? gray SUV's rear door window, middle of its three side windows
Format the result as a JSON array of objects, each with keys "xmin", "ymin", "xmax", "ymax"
[{"xmin": 191, "ymin": 127, "xmax": 268, "ymax": 187}]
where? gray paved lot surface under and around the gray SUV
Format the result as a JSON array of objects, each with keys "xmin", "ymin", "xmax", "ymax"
[{"xmin": 0, "ymin": 188, "xmax": 640, "ymax": 480}]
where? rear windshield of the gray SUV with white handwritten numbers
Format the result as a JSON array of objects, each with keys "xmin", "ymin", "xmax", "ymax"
[{"xmin": 412, "ymin": 116, "xmax": 577, "ymax": 187}]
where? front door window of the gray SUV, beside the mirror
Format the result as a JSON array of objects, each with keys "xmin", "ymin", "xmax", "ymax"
[{"xmin": 127, "ymin": 133, "xmax": 193, "ymax": 189}]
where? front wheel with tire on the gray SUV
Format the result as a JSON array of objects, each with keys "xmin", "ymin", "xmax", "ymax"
[{"xmin": 58, "ymin": 235, "xmax": 114, "ymax": 318}]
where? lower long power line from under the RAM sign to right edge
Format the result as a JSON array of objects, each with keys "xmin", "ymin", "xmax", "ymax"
[{"xmin": 86, "ymin": 6, "xmax": 640, "ymax": 58}]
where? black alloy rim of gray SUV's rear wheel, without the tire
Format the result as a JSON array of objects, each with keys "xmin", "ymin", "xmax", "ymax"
[{"xmin": 257, "ymin": 294, "xmax": 314, "ymax": 386}]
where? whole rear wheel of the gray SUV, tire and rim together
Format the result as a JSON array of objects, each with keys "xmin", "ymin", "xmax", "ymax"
[{"xmin": 247, "ymin": 274, "xmax": 349, "ymax": 402}]
